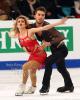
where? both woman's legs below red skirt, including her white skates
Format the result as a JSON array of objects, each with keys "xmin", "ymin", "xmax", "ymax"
[{"xmin": 15, "ymin": 60, "xmax": 40, "ymax": 96}]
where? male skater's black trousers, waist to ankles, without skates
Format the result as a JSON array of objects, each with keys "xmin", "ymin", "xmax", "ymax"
[{"xmin": 42, "ymin": 45, "xmax": 73, "ymax": 88}]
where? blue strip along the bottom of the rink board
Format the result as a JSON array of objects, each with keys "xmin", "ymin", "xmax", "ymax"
[{"xmin": 0, "ymin": 59, "xmax": 80, "ymax": 70}]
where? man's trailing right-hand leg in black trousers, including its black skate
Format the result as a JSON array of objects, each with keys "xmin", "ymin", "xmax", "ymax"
[{"xmin": 57, "ymin": 59, "xmax": 74, "ymax": 92}]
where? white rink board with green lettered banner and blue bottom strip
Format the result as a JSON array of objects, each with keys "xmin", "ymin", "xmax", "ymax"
[{"xmin": 0, "ymin": 19, "xmax": 80, "ymax": 70}]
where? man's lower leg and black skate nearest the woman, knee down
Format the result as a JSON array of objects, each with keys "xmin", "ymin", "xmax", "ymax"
[{"xmin": 40, "ymin": 55, "xmax": 54, "ymax": 94}]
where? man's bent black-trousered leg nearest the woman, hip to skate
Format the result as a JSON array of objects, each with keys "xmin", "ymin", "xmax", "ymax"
[{"xmin": 40, "ymin": 51, "xmax": 61, "ymax": 93}]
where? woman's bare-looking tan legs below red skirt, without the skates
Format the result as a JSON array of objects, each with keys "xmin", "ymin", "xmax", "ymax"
[{"xmin": 22, "ymin": 60, "xmax": 40, "ymax": 87}]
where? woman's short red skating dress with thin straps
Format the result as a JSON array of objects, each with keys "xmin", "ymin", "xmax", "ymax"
[{"xmin": 19, "ymin": 34, "xmax": 47, "ymax": 64}]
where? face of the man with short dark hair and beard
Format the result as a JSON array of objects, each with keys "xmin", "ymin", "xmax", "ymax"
[{"xmin": 34, "ymin": 10, "xmax": 45, "ymax": 24}]
